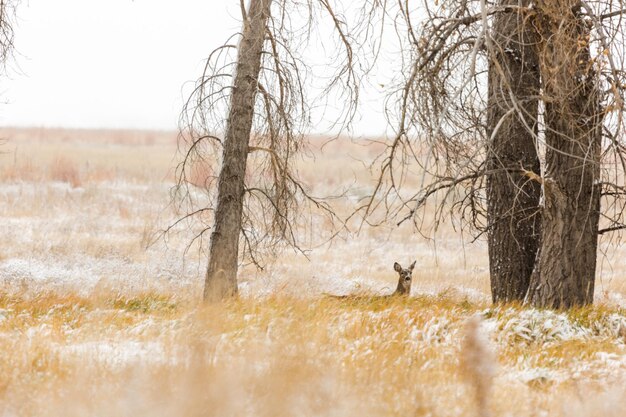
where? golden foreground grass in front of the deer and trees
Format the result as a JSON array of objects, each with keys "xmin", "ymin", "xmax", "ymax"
[{"xmin": 0, "ymin": 293, "xmax": 624, "ymax": 416}]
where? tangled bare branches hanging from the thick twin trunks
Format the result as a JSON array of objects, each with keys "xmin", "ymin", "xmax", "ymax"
[{"xmin": 359, "ymin": 0, "xmax": 626, "ymax": 240}]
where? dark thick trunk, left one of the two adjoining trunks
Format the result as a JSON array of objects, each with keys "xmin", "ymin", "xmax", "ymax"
[{"xmin": 487, "ymin": 0, "xmax": 541, "ymax": 302}]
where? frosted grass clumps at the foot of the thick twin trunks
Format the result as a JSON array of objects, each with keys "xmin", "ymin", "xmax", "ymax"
[{"xmin": 483, "ymin": 308, "xmax": 626, "ymax": 386}]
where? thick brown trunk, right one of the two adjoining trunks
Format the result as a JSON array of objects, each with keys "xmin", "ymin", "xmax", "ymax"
[{"xmin": 528, "ymin": 0, "xmax": 602, "ymax": 308}]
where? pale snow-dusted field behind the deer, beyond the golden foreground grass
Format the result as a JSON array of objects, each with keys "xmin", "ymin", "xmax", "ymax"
[{"xmin": 0, "ymin": 130, "xmax": 626, "ymax": 307}]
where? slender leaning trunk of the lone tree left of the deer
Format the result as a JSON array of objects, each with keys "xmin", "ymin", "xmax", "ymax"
[{"xmin": 204, "ymin": 0, "xmax": 272, "ymax": 302}]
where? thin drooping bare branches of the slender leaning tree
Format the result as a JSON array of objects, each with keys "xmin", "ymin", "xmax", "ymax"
[{"xmin": 169, "ymin": 0, "xmax": 378, "ymax": 274}]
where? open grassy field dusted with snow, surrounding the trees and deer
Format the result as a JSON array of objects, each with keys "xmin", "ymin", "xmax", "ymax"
[{"xmin": 0, "ymin": 129, "xmax": 626, "ymax": 417}]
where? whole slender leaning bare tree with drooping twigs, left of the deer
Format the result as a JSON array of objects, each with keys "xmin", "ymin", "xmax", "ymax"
[{"xmin": 176, "ymin": 0, "xmax": 370, "ymax": 301}]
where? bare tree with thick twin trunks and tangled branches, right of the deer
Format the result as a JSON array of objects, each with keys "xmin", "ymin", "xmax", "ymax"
[{"xmin": 361, "ymin": 0, "xmax": 626, "ymax": 307}]
